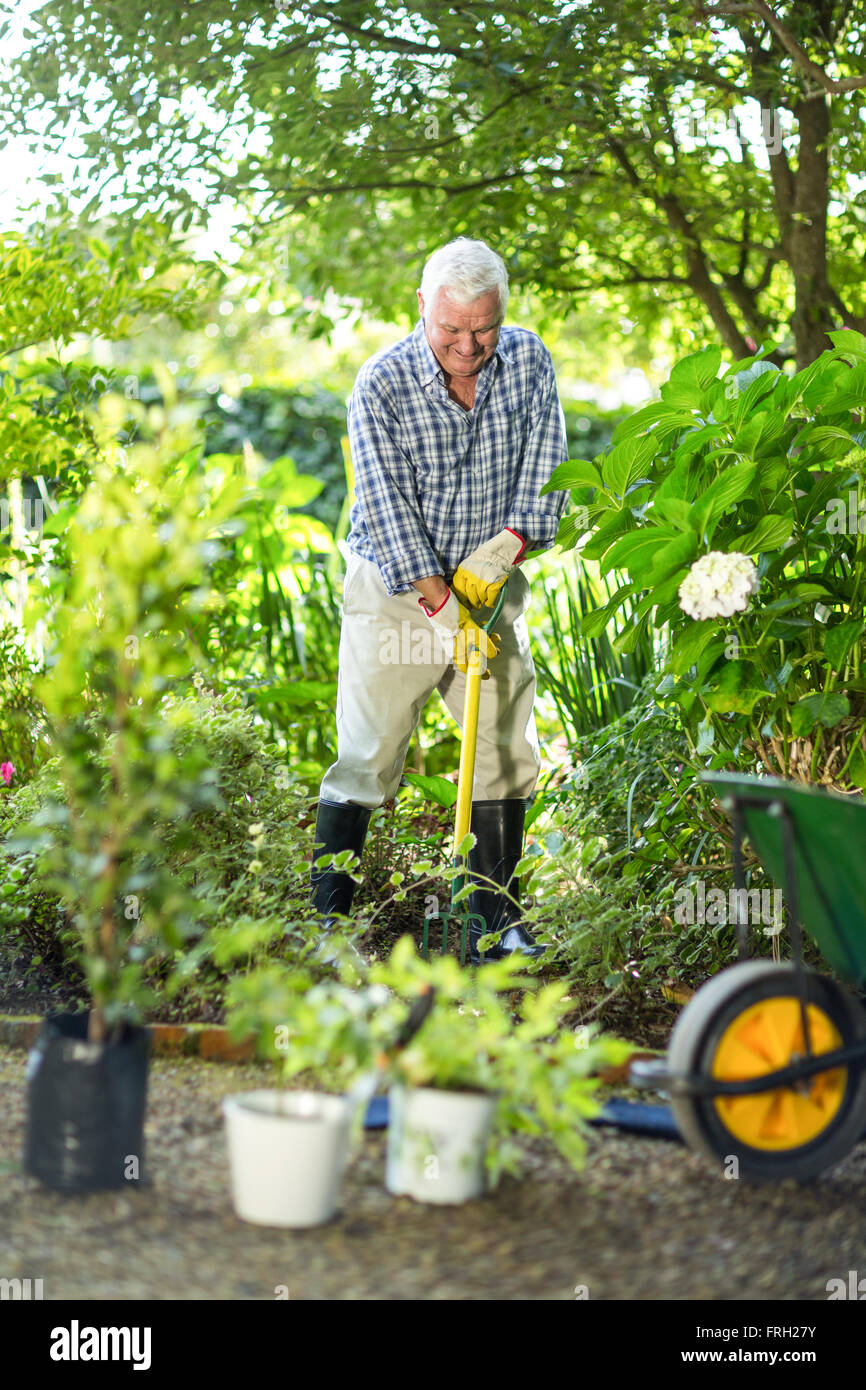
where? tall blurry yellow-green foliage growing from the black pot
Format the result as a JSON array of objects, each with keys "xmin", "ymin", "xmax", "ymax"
[{"xmin": 0, "ymin": 403, "xmax": 255, "ymax": 1037}]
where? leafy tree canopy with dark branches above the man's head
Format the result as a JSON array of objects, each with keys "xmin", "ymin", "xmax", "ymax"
[{"xmin": 1, "ymin": 0, "xmax": 866, "ymax": 366}]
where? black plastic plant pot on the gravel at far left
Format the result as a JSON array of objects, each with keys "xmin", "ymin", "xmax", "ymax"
[{"xmin": 24, "ymin": 1013, "xmax": 150, "ymax": 1193}]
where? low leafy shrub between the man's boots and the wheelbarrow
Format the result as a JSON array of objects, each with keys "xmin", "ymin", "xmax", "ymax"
[{"xmin": 511, "ymin": 676, "xmax": 795, "ymax": 990}]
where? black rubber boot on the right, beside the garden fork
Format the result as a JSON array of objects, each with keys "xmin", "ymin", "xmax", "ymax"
[{"xmin": 468, "ymin": 798, "xmax": 545, "ymax": 965}]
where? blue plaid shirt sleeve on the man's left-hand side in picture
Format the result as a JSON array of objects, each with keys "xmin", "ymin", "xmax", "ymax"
[{"xmin": 348, "ymin": 373, "xmax": 443, "ymax": 595}]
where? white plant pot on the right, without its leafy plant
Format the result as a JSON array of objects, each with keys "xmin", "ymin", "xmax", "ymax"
[{"xmin": 385, "ymin": 1086, "xmax": 496, "ymax": 1204}]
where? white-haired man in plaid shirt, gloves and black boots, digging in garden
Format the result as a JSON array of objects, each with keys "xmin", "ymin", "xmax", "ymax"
[{"xmin": 311, "ymin": 236, "xmax": 567, "ymax": 963}]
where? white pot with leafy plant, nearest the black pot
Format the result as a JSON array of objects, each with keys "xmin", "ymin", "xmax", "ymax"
[{"xmin": 222, "ymin": 960, "xmax": 405, "ymax": 1227}]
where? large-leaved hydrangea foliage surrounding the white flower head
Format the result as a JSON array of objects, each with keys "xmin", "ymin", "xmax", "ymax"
[{"xmin": 550, "ymin": 332, "xmax": 866, "ymax": 788}]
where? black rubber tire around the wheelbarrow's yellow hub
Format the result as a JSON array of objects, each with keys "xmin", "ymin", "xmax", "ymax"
[{"xmin": 667, "ymin": 960, "xmax": 866, "ymax": 1182}]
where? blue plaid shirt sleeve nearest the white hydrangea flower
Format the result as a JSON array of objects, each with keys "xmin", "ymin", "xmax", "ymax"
[{"xmin": 506, "ymin": 346, "xmax": 570, "ymax": 550}]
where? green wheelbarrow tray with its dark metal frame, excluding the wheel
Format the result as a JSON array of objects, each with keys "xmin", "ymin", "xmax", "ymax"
[{"xmin": 630, "ymin": 771, "xmax": 866, "ymax": 1122}]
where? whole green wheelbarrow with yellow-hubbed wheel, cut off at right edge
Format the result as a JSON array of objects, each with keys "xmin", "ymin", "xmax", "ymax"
[{"xmin": 630, "ymin": 773, "xmax": 866, "ymax": 1182}]
